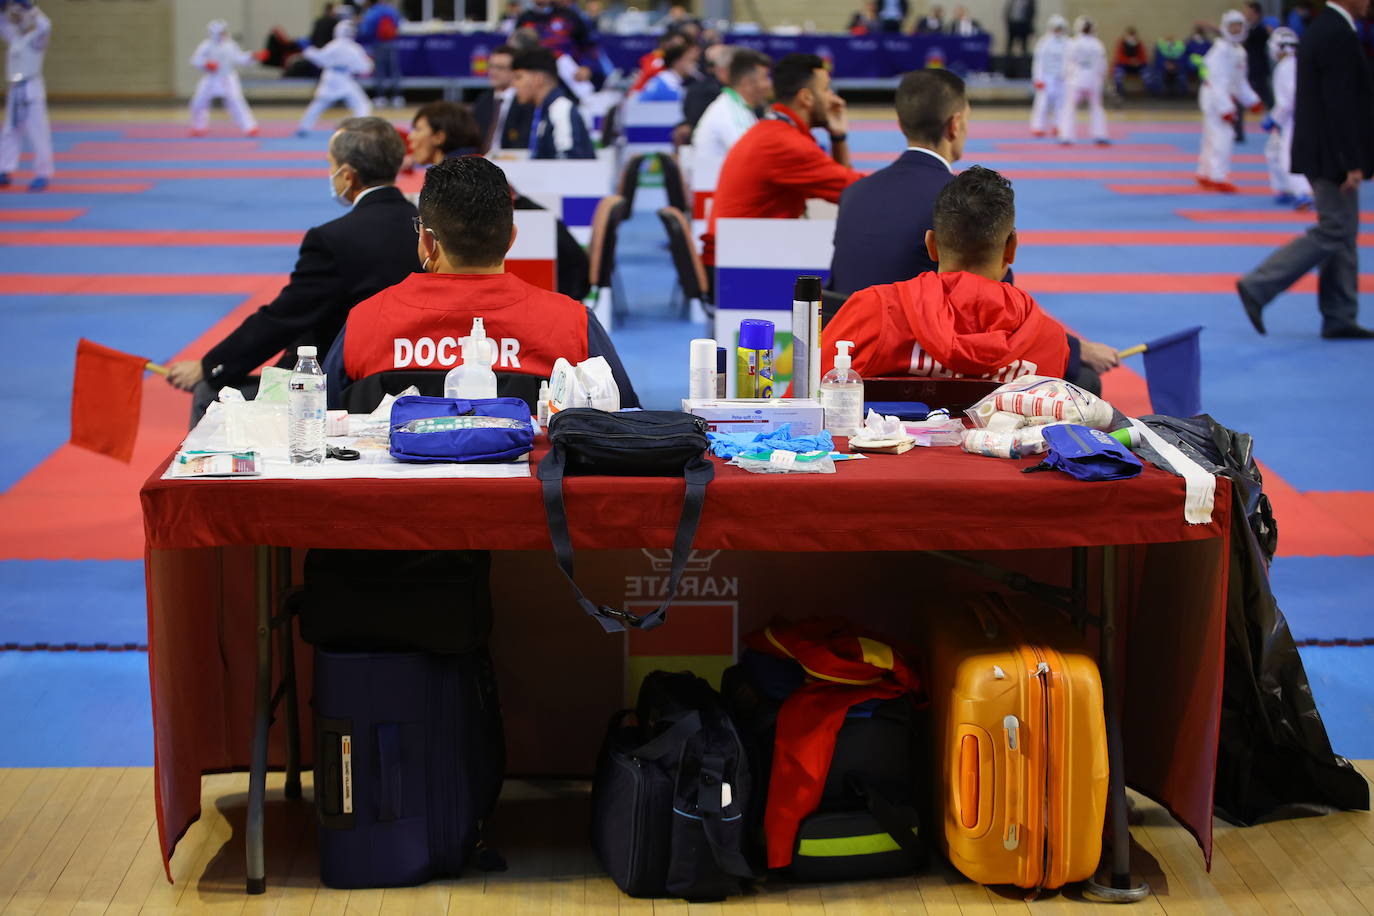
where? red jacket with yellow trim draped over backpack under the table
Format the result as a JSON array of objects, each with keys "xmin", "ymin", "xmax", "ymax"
[{"xmin": 746, "ymin": 619, "xmax": 921, "ymax": 868}]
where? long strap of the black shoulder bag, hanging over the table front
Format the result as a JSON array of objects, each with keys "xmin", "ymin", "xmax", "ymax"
[{"xmin": 539, "ymin": 445, "xmax": 716, "ymax": 633}]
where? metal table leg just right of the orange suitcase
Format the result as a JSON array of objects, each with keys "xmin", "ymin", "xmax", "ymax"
[{"xmin": 1083, "ymin": 547, "xmax": 1150, "ymax": 904}]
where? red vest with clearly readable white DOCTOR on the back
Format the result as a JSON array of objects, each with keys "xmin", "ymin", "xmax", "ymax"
[{"xmin": 344, "ymin": 273, "xmax": 587, "ymax": 379}]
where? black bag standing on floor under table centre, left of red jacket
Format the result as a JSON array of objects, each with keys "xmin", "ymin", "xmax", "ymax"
[{"xmin": 592, "ymin": 672, "xmax": 753, "ymax": 900}]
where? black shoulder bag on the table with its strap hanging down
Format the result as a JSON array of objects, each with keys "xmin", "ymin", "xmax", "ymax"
[{"xmin": 539, "ymin": 408, "xmax": 716, "ymax": 633}]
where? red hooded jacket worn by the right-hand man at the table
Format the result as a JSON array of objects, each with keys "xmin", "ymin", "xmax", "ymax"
[{"xmin": 820, "ymin": 271, "xmax": 1069, "ymax": 382}]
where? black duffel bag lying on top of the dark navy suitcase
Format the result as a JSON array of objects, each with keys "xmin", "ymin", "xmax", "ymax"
[{"xmin": 291, "ymin": 549, "xmax": 492, "ymax": 654}]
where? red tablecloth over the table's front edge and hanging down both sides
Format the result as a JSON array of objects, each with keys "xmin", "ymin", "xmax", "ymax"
[{"xmin": 142, "ymin": 448, "xmax": 1230, "ymax": 878}]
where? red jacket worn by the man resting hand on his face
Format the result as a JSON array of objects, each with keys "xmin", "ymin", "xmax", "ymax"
[{"xmin": 701, "ymin": 104, "xmax": 863, "ymax": 266}]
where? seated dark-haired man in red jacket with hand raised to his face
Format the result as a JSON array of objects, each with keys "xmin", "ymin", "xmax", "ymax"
[{"xmin": 702, "ymin": 54, "xmax": 863, "ymax": 266}]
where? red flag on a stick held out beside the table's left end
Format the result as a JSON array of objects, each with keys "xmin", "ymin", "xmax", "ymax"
[{"xmin": 71, "ymin": 338, "xmax": 148, "ymax": 463}]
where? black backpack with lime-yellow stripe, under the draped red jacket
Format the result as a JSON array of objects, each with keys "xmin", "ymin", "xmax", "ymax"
[{"xmin": 721, "ymin": 651, "xmax": 927, "ymax": 882}]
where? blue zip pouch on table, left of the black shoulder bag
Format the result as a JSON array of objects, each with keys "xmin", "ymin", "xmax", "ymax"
[{"xmin": 390, "ymin": 394, "xmax": 534, "ymax": 463}]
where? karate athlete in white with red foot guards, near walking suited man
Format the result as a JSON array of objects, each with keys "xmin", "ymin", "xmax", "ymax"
[{"xmin": 1198, "ymin": 10, "xmax": 1263, "ymax": 194}]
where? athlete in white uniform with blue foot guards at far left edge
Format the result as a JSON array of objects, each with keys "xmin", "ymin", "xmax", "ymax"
[{"xmin": 0, "ymin": 0, "xmax": 52, "ymax": 191}]
